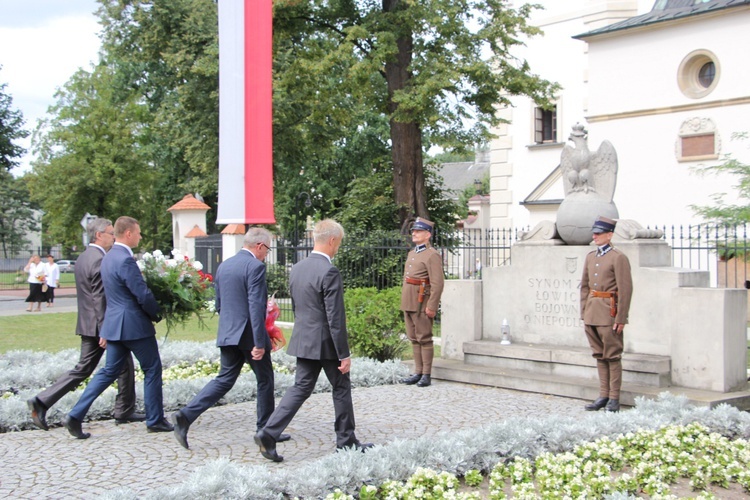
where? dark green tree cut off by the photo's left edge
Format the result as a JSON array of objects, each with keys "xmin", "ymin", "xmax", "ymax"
[{"xmin": 0, "ymin": 76, "xmax": 38, "ymax": 258}]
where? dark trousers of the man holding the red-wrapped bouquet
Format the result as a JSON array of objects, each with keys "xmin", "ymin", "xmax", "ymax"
[{"xmin": 180, "ymin": 346, "xmax": 276, "ymax": 429}]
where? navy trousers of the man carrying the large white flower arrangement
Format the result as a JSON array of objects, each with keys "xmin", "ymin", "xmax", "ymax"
[{"xmin": 68, "ymin": 337, "xmax": 164, "ymax": 427}]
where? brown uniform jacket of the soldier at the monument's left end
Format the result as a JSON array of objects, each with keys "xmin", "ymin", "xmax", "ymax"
[{"xmin": 401, "ymin": 245, "xmax": 444, "ymax": 312}]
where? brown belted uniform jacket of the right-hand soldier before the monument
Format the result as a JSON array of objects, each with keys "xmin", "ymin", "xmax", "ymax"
[{"xmin": 581, "ymin": 247, "xmax": 633, "ymax": 326}]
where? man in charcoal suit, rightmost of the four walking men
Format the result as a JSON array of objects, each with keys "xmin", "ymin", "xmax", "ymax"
[{"xmin": 255, "ymin": 219, "xmax": 372, "ymax": 462}]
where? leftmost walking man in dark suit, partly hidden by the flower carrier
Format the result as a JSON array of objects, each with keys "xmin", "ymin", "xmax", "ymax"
[{"xmin": 28, "ymin": 218, "xmax": 146, "ymax": 430}]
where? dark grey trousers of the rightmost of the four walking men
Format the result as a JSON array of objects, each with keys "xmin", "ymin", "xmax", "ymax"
[{"xmin": 264, "ymin": 358, "xmax": 357, "ymax": 447}]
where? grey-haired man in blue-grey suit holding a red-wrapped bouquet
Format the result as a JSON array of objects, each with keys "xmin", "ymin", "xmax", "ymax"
[{"xmin": 172, "ymin": 227, "xmax": 289, "ymax": 448}]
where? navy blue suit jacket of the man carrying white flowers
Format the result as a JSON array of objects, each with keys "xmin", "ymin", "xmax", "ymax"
[{"xmin": 99, "ymin": 244, "xmax": 160, "ymax": 341}]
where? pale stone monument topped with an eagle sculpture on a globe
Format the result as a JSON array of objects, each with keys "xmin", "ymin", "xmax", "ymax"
[{"xmin": 433, "ymin": 124, "xmax": 750, "ymax": 408}]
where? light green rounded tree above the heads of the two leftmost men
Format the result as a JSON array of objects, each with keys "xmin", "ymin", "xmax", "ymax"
[{"xmin": 29, "ymin": 64, "xmax": 159, "ymax": 250}]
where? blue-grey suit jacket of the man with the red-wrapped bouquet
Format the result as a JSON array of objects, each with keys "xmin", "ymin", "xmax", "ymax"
[{"xmin": 214, "ymin": 249, "xmax": 272, "ymax": 350}]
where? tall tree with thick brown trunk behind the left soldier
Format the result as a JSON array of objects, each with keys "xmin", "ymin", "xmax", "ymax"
[{"xmin": 274, "ymin": 0, "xmax": 557, "ymax": 228}]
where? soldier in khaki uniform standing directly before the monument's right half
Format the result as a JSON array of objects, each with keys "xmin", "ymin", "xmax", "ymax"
[{"xmin": 581, "ymin": 217, "xmax": 633, "ymax": 412}]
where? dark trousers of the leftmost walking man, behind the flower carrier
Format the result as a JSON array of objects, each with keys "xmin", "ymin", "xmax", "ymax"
[{"xmin": 36, "ymin": 336, "xmax": 135, "ymax": 418}]
